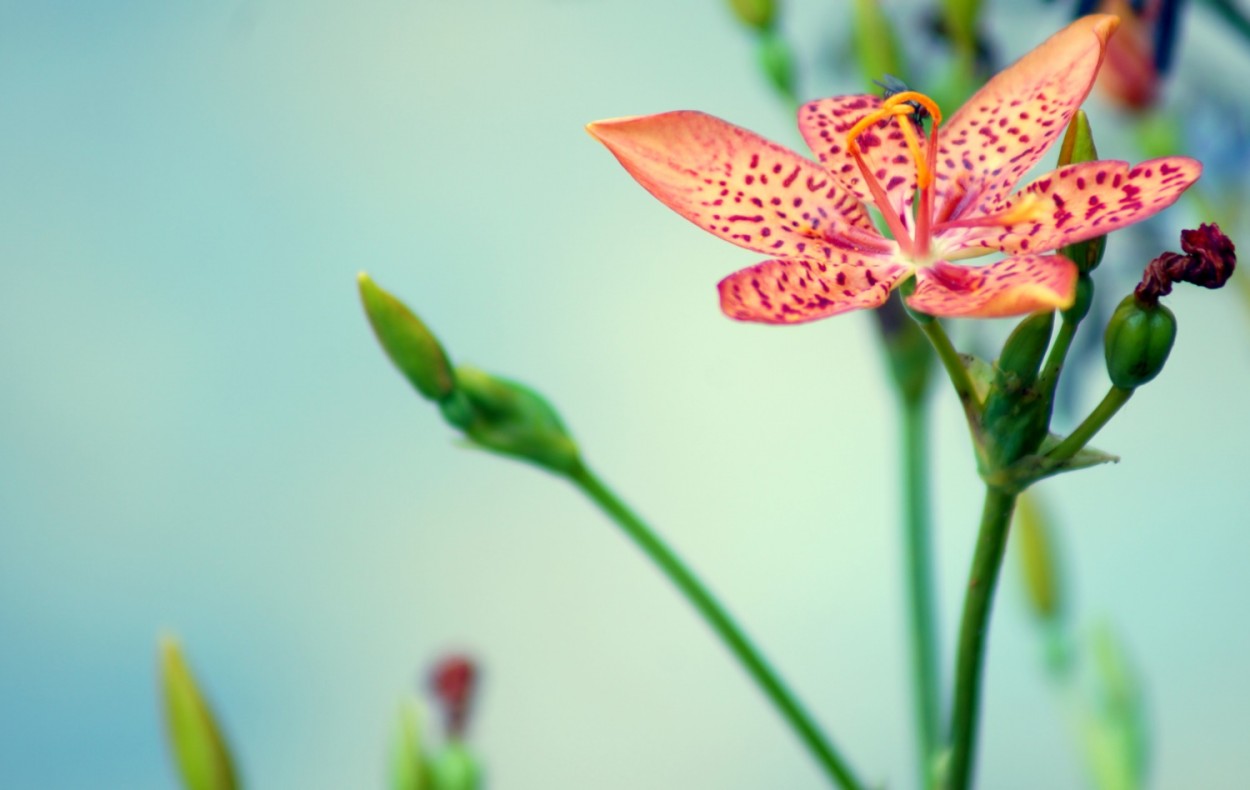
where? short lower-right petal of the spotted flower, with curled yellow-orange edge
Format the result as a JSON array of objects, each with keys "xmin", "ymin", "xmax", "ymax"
[{"xmin": 908, "ymin": 255, "xmax": 1078, "ymax": 319}]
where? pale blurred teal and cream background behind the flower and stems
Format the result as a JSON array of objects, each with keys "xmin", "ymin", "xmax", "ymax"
[{"xmin": 0, "ymin": 0, "xmax": 1250, "ymax": 790}]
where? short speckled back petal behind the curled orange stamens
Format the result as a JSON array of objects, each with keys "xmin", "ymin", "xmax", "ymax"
[{"xmin": 799, "ymin": 95, "xmax": 925, "ymax": 228}]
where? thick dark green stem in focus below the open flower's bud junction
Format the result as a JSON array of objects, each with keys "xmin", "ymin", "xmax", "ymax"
[{"xmin": 945, "ymin": 486, "xmax": 1016, "ymax": 790}]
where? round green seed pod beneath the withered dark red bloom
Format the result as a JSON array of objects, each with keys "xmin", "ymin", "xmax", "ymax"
[{"xmin": 1104, "ymin": 294, "xmax": 1176, "ymax": 390}]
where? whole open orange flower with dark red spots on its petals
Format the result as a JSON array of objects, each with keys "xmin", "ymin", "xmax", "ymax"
[{"xmin": 588, "ymin": 15, "xmax": 1201, "ymax": 324}]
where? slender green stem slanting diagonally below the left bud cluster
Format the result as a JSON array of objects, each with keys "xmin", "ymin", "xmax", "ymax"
[{"xmin": 569, "ymin": 465, "xmax": 864, "ymax": 790}]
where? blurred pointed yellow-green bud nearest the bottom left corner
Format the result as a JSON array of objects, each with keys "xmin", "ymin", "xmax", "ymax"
[{"xmin": 158, "ymin": 636, "xmax": 239, "ymax": 790}]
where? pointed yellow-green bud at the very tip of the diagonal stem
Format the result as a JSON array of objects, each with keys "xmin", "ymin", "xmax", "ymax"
[{"xmin": 356, "ymin": 271, "xmax": 455, "ymax": 401}]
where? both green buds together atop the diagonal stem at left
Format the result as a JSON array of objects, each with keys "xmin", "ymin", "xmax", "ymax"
[{"xmin": 358, "ymin": 273, "xmax": 581, "ymax": 475}]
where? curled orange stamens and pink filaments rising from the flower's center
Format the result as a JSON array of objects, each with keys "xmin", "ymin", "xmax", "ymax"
[{"xmin": 846, "ymin": 90, "xmax": 941, "ymax": 261}]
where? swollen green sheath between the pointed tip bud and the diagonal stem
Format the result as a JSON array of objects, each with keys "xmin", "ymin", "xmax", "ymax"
[{"xmin": 449, "ymin": 366, "xmax": 581, "ymax": 474}]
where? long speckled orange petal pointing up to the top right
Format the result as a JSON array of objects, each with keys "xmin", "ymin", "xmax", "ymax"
[{"xmin": 936, "ymin": 15, "xmax": 1119, "ymax": 220}]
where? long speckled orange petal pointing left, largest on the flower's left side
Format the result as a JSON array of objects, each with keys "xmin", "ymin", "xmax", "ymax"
[{"xmin": 586, "ymin": 111, "xmax": 884, "ymax": 259}]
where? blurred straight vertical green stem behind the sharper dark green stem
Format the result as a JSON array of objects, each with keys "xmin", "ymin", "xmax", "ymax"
[{"xmin": 901, "ymin": 395, "xmax": 940, "ymax": 788}]
